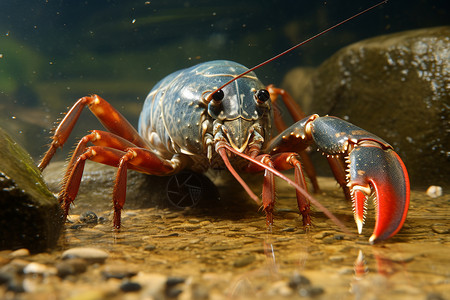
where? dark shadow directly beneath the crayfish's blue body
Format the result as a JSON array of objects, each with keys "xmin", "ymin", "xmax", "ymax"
[{"xmin": 140, "ymin": 171, "xmax": 263, "ymax": 220}]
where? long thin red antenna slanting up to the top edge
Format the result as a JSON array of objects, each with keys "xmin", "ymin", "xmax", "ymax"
[{"xmin": 205, "ymin": 0, "xmax": 388, "ymax": 103}]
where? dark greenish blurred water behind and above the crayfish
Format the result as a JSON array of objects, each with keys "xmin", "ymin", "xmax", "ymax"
[{"xmin": 0, "ymin": 0, "xmax": 449, "ymax": 157}]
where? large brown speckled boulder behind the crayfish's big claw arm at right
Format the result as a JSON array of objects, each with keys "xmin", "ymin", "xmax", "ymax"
[{"xmin": 283, "ymin": 26, "xmax": 450, "ymax": 187}]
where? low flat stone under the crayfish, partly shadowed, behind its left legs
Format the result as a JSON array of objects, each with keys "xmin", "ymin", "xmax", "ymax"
[{"xmin": 43, "ymin": 161, "xmax": 262, "ymax": 219}]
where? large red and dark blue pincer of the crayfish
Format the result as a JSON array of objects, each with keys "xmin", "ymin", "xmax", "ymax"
[{"xmin": 348, "ymin": 144, "xmax": 409, "ymax": 243}]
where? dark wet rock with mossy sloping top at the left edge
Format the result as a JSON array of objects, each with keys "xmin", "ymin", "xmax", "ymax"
[{"xmin": 0, "ymin": 129, "xmax": 63, "ymax": 252}]
